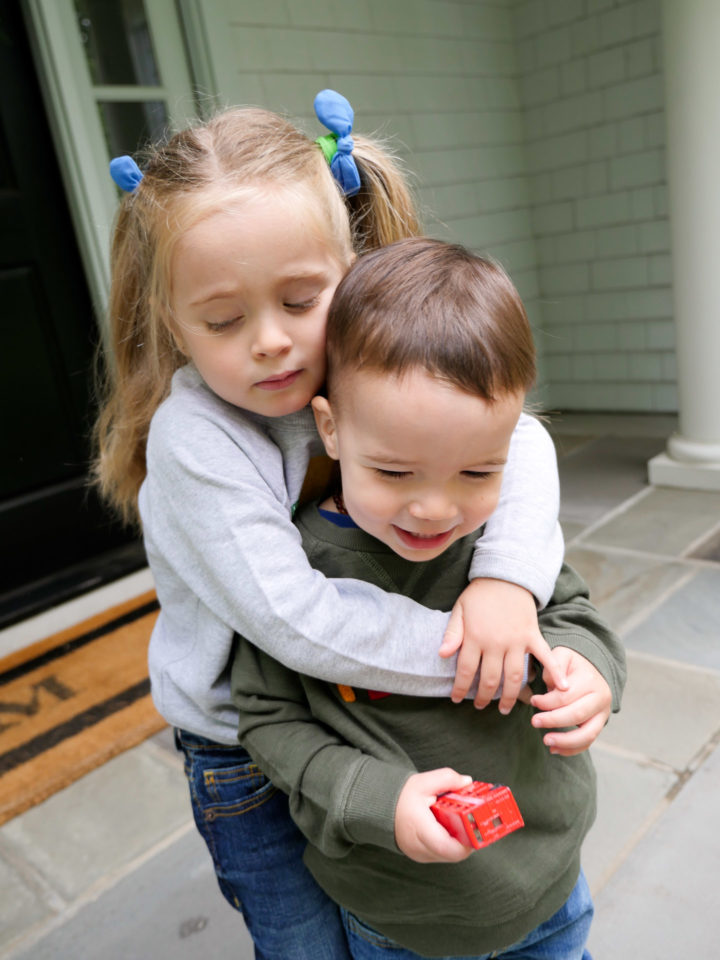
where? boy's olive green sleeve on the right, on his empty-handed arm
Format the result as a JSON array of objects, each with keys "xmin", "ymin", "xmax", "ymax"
[{"xmin": 538, "ymin": 564, "xmax": 627, "ymax": 713}]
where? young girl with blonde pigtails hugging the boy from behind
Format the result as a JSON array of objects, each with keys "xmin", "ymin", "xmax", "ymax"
[{"xmin": 96, "ymin": 91, "xmax": 562, "ymax": 960}]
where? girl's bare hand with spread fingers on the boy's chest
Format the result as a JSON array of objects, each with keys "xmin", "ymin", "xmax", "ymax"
[{"xmin": 439, "ymin": 579, "xmax": 567, "ymax": 713}]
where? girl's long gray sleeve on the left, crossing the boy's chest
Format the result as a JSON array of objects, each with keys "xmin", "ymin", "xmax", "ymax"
[{"xmin": 141, "ymin": 402, "xmax": 455, "ymax": 696}]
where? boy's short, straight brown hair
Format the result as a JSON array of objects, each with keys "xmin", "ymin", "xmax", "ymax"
[{"xmin": 327, "ymin": 237, "xmax": 536, "ymax": 402}]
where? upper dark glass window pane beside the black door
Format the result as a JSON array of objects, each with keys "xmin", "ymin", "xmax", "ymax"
[{"xmin": 75, "ymin": 0, "xmax": 160, "ymax": 87}]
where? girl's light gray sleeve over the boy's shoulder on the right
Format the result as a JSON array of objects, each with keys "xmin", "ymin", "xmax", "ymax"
[{"xmin": 470, "ymin": 414, "xmax": 564, "ymax": 609}]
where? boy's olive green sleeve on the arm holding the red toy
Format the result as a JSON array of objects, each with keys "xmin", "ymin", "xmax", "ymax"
[{"xmin": 231, "ymin": 640, "xmax": 414, "ymax": 857}]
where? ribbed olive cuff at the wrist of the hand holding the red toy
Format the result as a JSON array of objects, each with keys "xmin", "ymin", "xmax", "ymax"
[{"xmin": 343, "ymin": 757, "xmax": 413, "ymax": 853}]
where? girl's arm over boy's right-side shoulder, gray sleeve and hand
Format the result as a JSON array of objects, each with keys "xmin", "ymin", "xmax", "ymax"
[{"xmin": 440, "ymin": 414, "xmax": 566, "ymax": 713}]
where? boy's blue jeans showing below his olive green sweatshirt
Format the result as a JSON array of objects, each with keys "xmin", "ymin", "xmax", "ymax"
[{"xmin": 342, "ymin": 871, "xmax": 594, "ymax": 960}]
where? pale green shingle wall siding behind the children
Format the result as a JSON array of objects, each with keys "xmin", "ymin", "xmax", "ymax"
[{"xmin": 193, "ymin": 0, "xmax": 677, "ymax": 411}]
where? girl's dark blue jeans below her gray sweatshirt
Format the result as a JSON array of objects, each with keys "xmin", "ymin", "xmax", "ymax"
[{"xmin": 175, "ymin": 730, "xmax": 350, "ymax": 960}]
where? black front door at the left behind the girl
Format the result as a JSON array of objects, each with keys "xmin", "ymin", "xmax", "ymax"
[{"xmin": 0, "ymin": 0, "xmax": 144, "ymax": 626}]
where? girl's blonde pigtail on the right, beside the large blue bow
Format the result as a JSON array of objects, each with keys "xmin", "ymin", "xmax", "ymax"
[{"xmin": 345, "ymin": 135, "xmax": 420, "ymax": 253}]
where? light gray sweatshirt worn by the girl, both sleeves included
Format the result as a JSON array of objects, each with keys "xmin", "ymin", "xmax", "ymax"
[{"xmin": 139, "ymin": 364, "xmax": 563, "ymax": 744}]
